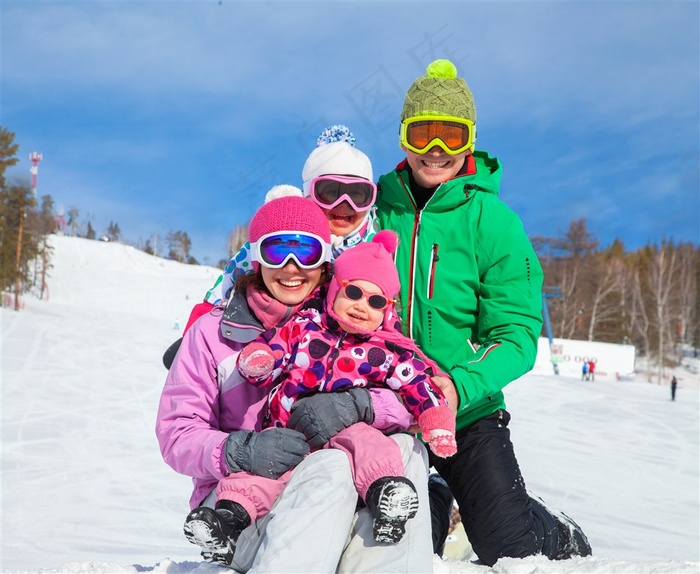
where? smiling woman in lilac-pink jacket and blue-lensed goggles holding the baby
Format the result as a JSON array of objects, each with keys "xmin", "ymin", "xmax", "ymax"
[{"xmin": 156, "ymin": 197, "xmax": 432, "ymax": 572}]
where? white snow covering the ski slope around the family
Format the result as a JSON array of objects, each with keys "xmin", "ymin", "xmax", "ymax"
[{"xmin": 0, "ymin": 236, "xmax": 700, "ymax": 574}]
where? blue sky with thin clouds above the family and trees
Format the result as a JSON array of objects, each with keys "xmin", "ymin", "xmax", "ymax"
[{"xmin": 0, "ymin": 0, "xmax": 700, "ymax": 263}]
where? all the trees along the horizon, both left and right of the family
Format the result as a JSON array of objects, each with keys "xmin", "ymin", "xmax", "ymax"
[{"xmin": 0, "ymin": 127, "xmax": 700, "ymax": 374}]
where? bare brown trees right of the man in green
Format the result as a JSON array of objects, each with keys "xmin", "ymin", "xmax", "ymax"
[{"xmin": 532, "ymin": 219, "xmax": 700, "ymax": 372}]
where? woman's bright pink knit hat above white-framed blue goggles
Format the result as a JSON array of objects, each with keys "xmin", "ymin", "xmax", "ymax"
[{"xmin": 248, "ymin": 195, "xmax": 331, "ymax": 243}]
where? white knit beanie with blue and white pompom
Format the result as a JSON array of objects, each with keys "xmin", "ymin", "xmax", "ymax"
[{"xmin": 301, "ymin": 125, "xmax": 374, "ymax": 195}]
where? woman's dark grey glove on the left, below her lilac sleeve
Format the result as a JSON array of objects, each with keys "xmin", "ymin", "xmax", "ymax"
[{"xmin": 224, "ymin": 428, "xmax": 309, "ymax": 479}]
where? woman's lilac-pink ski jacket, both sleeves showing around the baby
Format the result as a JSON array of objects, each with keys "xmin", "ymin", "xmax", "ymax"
[{"xmin": 156, "ymin": 307, "xmax": 413, "ymax": 508}]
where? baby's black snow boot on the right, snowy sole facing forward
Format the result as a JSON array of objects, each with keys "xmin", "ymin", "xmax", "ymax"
[{"xmin": 365, "ymin": 476, "xmax": 418, "ymax": 544}]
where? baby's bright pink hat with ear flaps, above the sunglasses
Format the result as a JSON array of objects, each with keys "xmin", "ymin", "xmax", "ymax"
[{"xmin": 326, "ymin": 230, "xmax": 401, "ymax": 336}]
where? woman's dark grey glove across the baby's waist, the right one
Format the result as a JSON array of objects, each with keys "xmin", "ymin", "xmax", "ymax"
[{"xmin": 287, "ymin": 388, "xmax": 374, "ymax": 448}]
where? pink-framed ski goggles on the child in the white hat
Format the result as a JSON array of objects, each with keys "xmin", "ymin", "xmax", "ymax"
[{"xmin": 304, "ymin": 175, "xmax": 377, "ymax": 212}]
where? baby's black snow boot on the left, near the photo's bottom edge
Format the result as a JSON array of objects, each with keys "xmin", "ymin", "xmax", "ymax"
[{"xmin": 183, "ymin": 500, "xmax": 250, "ymax": 566}]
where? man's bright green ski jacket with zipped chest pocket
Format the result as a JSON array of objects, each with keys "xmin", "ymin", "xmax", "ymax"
[{"xmin": 377, "ymin": 151, "xmax": 543, "ymax": 430}]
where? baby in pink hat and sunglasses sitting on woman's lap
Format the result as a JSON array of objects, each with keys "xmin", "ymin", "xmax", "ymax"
[{"xmin": 221, "ymin": 231, "xmax": 457, "ymax": 544}]
